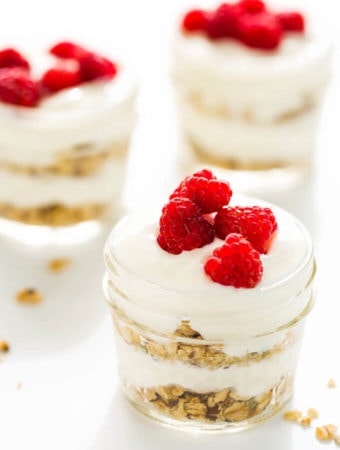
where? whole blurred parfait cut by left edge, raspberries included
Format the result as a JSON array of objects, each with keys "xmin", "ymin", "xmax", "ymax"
[{"xmin": 0, "ymin": 41, "xmax": 136, "ymax": 226}]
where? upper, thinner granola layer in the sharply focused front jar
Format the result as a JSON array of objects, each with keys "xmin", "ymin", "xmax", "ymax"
[{"xmin": 115, "ymin": 320, "xmax": 293, "ymax": 369}]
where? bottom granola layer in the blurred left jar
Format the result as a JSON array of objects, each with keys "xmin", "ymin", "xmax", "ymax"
[{"xmin": 0, "ymin": 203, "xmax": 109, "ymax": 226}]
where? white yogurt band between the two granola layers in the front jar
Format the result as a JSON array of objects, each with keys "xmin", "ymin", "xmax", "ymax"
[{"xmin": 117, "ymin": 337, "xmax": 299, "ymax": 397}]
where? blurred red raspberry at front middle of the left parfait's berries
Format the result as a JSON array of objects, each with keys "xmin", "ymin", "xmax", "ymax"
[{"xmin": 41, "ymin": 65, "xmax": 82, "ymax": 92}]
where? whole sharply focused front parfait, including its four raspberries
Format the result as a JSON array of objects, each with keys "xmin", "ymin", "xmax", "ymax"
[{"xmin": 104, "ymin": 169, "xmax": 315, "ymax": 429}]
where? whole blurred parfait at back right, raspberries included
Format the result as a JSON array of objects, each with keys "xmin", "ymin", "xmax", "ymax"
[{"xmin": 172, "ymin": 0, "xmax": 331, "ymax": 188}]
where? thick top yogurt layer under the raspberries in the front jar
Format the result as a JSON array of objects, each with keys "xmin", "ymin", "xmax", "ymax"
[{"xmin": 105, "ymin": 195, "xmax": 314, "ymax": 339}]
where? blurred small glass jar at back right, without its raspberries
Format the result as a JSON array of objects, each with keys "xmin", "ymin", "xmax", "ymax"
[{"xmin": 172, "ymin": 13, "xmax": 332, "ymax": 193}]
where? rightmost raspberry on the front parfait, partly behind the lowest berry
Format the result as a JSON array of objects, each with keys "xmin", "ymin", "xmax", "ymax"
[{"xmin": 214, "ymin": 206, "xmax": 277, "ymax": 253}]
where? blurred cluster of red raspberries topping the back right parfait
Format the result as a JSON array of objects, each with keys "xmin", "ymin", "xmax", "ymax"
[{"xmin": 181, "ymin": 0, "xmax": 305, "ymax": 50}]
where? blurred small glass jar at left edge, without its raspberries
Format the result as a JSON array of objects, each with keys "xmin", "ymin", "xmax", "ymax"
[{"xmin": 0, "ymin": 60, "xmax": 137, "ymax": 242}]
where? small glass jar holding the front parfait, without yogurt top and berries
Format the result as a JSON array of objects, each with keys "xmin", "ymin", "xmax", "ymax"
[{"xmin": 104, "ymin": 211, "xmax": 315, "ymax": 431}]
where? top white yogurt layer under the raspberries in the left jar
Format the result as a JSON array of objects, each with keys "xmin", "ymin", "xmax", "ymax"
[{"xmin": 0, "ymin": 67, "xmax": 136, "ymax": 166}]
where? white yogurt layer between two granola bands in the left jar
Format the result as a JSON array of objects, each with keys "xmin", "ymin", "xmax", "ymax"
[{"xmin": 0, "ymin": 159, "xmax": 125, "ymax": 208}]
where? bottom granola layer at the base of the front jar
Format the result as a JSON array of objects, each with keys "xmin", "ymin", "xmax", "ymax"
[{"xmin": 126, "ymin": 377, "xmax": 292, "ymax": 423}]
